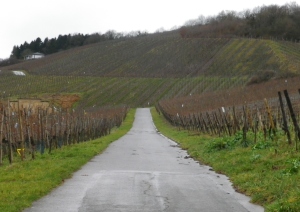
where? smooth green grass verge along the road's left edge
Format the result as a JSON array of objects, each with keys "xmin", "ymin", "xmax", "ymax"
[{"xmin": 0, "ymin": 110, "xmax": 135, "ymax": 212}]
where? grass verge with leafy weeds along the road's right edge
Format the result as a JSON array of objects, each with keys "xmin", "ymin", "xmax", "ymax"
[{"xmin": 152, "ymin": 109, "xmax": 300, "ymax": 211}]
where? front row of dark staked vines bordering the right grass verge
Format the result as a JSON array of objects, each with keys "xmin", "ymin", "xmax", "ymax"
[{"xmin": 156, "ymin": 89, "xmax": 300, "ymax": 149}]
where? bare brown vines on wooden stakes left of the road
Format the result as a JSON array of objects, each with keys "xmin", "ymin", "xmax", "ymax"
[{"xmin": 0, "ymin": 99, "xmax": 128, "ymax": 164}]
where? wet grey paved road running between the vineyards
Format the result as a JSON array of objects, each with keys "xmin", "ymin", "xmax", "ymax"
[{"xmin": 25, "ymin": 109, "xmax": 263, "ymax": 212}]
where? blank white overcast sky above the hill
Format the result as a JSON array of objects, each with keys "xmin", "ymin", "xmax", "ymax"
[{"xmin": 0, "ymin": 0, "xmax": 290, "ymax": 58}]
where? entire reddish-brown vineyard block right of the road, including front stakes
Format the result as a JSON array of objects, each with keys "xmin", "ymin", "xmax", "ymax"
[{"xmin": 156, "ymin": 78, "xmax": 300, "ymax": 150}]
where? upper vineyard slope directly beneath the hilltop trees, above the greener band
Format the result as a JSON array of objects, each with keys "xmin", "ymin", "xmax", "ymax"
[{"xmin": 3, "ymin": 34, "xmax": 300, "ymax": 78}]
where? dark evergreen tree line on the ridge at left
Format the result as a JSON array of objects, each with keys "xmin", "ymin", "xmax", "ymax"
[{"xmin": 10, "ymin": 30, "xmax": 147, "ymax": 59}]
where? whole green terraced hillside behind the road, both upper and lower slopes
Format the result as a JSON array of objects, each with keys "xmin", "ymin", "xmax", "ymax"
[{"xmin": 0, "ymin": 32, "xmax": 300, "ymax": 107}]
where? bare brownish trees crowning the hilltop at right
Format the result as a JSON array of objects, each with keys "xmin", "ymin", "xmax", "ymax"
[{"xmin": 179, "ymin": 2, "xmax": 300, "ymax": 42}]
